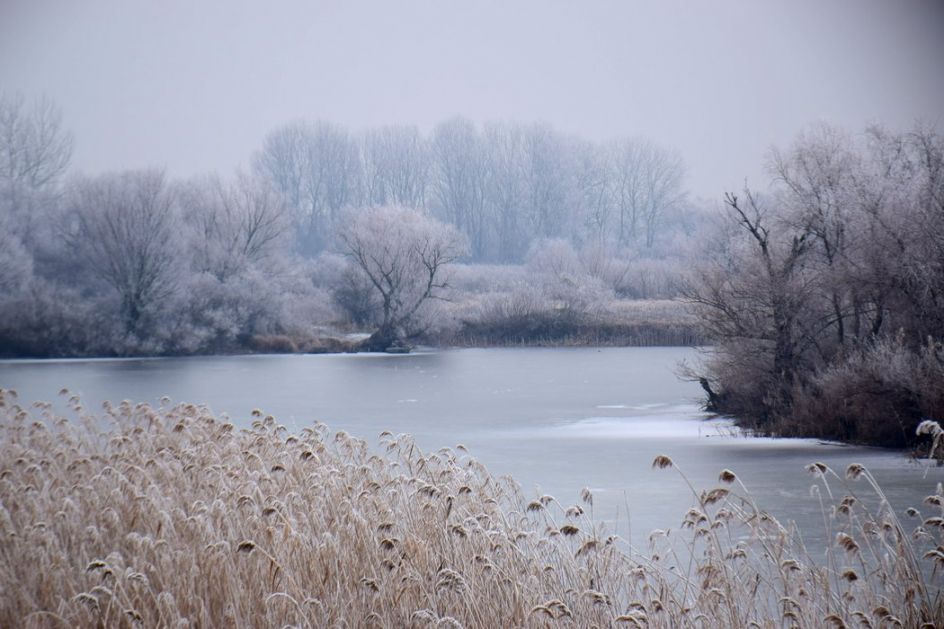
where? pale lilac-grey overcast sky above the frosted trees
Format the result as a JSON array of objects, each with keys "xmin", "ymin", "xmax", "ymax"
[{"xmin": 0, "ymin": 0, "xmax": 944, "ymax": 196}]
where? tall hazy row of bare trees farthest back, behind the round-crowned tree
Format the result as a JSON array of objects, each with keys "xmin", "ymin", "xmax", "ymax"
[{"xmin": 253, "ymin": 118, "xmax": 686, "ymax": 263}]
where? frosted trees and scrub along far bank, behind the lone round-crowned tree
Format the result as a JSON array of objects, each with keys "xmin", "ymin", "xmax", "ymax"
[{"xmin": 0, "ymin": 97, "xmax": 704, "ymax": 357}]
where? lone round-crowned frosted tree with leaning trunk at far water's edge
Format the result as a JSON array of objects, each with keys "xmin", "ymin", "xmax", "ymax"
[{"xmin": 340, "ymin": 207, "xmax": 465, "ymax": 351}]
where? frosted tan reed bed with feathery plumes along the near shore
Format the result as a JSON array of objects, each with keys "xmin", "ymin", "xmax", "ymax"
[{"xmin": 0, "ymin": 390, "xmax": 944, "ymax": 627}]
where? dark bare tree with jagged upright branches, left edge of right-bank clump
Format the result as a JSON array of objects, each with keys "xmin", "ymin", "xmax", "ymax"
[{"xmin": 687, "ymin": 191, "xmax": 816, "ymax": 426}]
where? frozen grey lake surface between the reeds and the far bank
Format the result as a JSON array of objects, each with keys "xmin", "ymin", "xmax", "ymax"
[{"xmin": 0, "ymin": 348, "xmax": 944, "ymax": 547}]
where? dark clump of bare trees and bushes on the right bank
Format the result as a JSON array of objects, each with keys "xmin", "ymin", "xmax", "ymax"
[{"xmin": 688, "ymin": 126, "xmax": 944, "ymax": 446}]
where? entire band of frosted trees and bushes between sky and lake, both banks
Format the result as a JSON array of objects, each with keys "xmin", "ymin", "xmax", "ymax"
[{"xmin": 0, "ymin": 96, "xmax": 944, "ymax": 445}]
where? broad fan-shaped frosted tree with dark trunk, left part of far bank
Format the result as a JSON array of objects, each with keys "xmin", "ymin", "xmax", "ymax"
[{"xmin": 69, "ymin": 171, "xmax": 180, "ymax": 335}]
